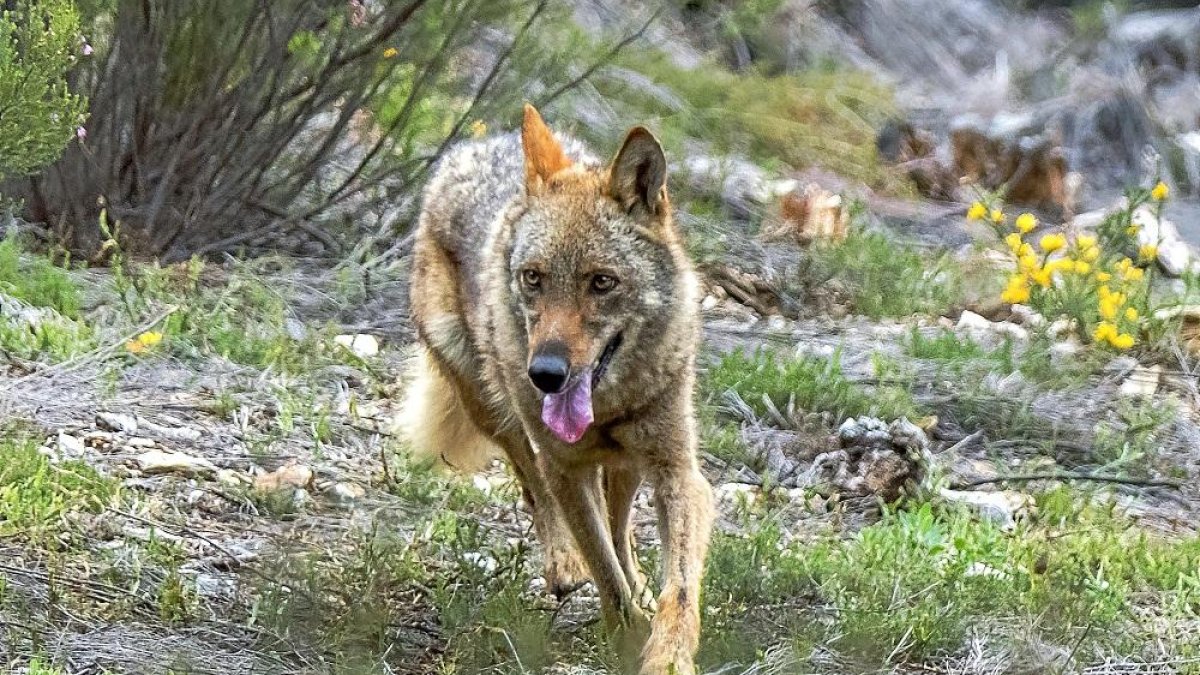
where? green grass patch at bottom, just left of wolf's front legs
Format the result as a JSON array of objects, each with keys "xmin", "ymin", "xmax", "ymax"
[{"xmin": 254, "ymin": 453, "xmax": 612, "ymax": 675}]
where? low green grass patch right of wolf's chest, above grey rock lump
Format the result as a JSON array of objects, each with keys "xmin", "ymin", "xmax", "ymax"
[{"xmin": 702, "ymin": 350, "xmax": 920, "ymax": 422}]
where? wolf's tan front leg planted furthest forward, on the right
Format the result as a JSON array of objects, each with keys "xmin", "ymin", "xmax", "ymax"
[{"xmin": 641, "ymin": 443, "xmax": 713, "ymax": 675}]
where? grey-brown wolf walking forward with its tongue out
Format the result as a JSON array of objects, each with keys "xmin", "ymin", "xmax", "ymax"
[{"xmin": 400, "ymin": 104, "xmax": 713, "ymax": 675}]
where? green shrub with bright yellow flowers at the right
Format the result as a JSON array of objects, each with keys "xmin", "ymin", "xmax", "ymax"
[{"xmin": 967, "ymin": 181, "xmax": 1169, "ymax": 350}]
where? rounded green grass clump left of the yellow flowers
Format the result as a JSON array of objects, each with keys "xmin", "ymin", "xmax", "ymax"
[{"xmin": 802, "ymin": 226, "xmax": 966, "ymax": 318}]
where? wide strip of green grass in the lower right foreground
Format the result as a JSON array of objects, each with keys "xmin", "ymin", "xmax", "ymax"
[{"xmin": 702, "ymin": 491, "xmax": 1200, "ymax": 671}]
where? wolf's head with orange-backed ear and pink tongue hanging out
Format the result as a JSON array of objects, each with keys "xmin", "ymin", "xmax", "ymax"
[{"xmin": 509, "ymin": 106, "xmax": 678, "ymax": 443}]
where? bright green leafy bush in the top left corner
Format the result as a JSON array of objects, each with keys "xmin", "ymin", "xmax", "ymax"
[{"xmin": 0, "ymin": 0, "xmax": 86, "ymax": 179}]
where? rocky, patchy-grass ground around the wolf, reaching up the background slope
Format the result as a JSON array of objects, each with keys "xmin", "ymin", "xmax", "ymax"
[{"xmin": 7, "ymin": 0, "xmax": 1200, "ymax": 675}]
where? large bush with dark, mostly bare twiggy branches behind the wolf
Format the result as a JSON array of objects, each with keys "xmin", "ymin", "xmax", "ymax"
[{"xmin": 9, "ymin": 0, "xmax": 638, "ymax": 262}]
